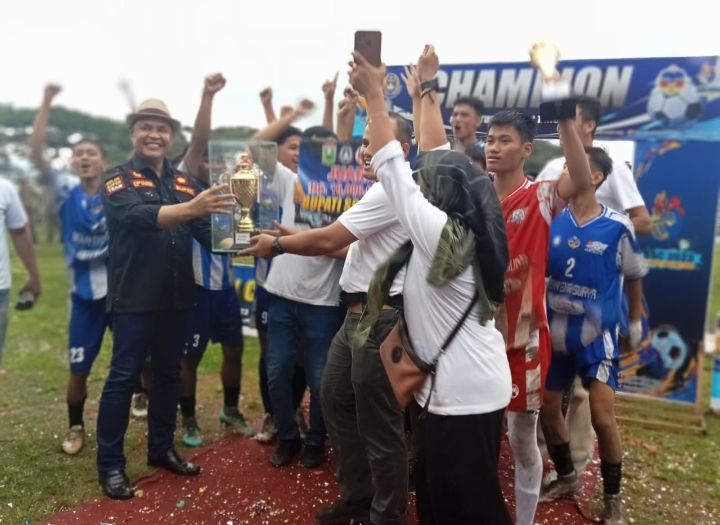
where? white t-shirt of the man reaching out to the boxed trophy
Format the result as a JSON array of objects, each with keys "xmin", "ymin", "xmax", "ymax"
[{"xmin": 338, "ymin": 178, "xmax": 409, "ymax": 295}]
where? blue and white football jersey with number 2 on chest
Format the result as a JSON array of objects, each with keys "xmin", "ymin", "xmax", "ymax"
[{"xmin": 547, "ymin": 206, "xmax": 647, "ymax": 362}]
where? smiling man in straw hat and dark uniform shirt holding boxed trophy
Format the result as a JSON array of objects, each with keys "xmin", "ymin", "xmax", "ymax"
[{"xmin": 97, "ymin": 99, "xmax": 233, "ymax": 499}]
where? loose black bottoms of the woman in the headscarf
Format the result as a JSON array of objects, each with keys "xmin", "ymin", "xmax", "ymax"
[{"xmin": 415, "ymin": 409, "xmax": 512, "ymax": 525}]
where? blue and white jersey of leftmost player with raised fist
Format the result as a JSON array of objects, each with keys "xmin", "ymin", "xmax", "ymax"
[{"xmin": 54, "ymin": 174, "xmax": 109, "ymax": 300}]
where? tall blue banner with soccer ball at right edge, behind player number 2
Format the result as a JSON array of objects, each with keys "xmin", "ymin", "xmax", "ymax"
[{"xmin": 621, "ymin": 140, "xmax": 720, "ymax": 404}]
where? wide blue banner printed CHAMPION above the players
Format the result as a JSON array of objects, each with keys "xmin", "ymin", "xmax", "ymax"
[{"xmin": 387, "ymin": 56, "xmax": 720, "ymax": 141}]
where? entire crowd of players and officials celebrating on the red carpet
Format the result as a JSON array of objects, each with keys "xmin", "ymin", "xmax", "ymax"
[{"xmin": 0, "ymin": 42, "xmax": 650, "ymax": 524}]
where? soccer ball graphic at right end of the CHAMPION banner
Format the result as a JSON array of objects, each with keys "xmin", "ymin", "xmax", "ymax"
[{"xmin": 647, "ymin": 64, "xmax": 702, "ymax": 127}]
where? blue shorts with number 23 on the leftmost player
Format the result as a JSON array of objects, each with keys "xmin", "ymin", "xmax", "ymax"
[{"xmin": 68, "ymin": 295, "xmax": 110, "ymax": 373}]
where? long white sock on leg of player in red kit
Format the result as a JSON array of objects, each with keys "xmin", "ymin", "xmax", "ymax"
[{"xmin": 507, "ymin": 412, "xmax": 542, "ymax": 525}]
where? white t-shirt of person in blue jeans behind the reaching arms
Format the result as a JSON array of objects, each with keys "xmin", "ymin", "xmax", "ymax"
[{"xmin": 264, "ymin": 162, "xmax": 342, "ymax": 306}]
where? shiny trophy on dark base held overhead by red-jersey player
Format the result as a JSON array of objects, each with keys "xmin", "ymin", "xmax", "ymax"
[{"xmin": 530, "ymin": 41, "xmax": 576, "ymax": 121}]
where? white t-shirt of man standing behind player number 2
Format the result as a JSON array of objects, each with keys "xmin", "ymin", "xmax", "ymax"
[{"xmin": 535, "ymin": 157, "xmax": 645, "ymax": 213}]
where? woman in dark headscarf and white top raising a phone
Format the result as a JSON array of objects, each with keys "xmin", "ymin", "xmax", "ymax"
[{"xmin": 350, "ymin": 47, "xmax": 511, "ymax": 525}]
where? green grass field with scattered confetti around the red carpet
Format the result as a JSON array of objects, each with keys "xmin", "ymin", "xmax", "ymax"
[{"xmin": 0, "ymin": 245, "xmax": 720, "ymax": 525}]
